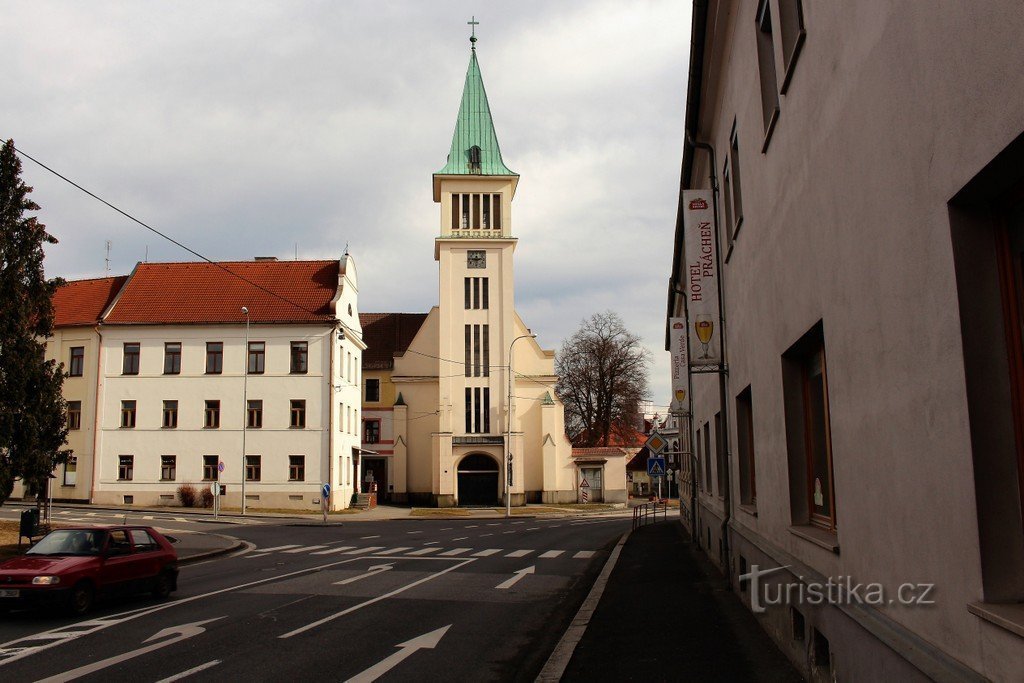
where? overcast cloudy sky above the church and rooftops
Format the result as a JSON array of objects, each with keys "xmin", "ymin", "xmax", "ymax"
[{"xmin": 0, "ymin": 0, "xmax": 690, "ymax": 411}]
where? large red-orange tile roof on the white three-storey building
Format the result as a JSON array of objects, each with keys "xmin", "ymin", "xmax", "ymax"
[{"xmin": 103, "ymin": 261, "xmax": 341, "ymax": 325}]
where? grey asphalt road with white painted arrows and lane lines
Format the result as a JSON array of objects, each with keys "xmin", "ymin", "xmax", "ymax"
[{"xmin": 0, "ymin": 515, "xmax": 630, "ymax": 681}]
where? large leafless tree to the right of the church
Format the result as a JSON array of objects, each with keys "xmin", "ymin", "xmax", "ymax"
[{"xmin": 555, "ymin": 310, "xmax": 650, "ymax": 446}]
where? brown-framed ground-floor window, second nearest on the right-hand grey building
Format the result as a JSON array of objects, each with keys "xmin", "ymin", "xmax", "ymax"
[{"xmin": 782, "ymin": 322, "xmax": 836, "ymax": 532}]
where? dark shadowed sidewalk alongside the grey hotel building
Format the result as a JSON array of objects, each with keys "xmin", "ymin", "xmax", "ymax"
[{"xmin": 561, "ymin": 518, "xmax": 803, "ymax": 683}]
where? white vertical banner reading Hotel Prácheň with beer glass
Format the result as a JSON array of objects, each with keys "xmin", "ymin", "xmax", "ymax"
[{"xmin": 683, "ymin": 189, "xmax": 722, "ymax": 368}]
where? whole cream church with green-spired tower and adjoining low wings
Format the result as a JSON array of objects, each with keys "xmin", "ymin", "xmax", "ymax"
[{"xmin": 360, "ymin": 38, "xmax": 626, "ymax": 507}]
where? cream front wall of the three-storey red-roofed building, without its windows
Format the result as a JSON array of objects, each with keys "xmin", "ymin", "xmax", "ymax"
[{"xmin": 94, "ymin": 325, "xmax": 358, "ymax": 509}]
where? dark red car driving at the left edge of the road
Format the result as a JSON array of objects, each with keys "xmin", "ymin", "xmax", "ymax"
[{"xmin": 0, "ymin": 526, "xmax": 178, "ymax": 614}]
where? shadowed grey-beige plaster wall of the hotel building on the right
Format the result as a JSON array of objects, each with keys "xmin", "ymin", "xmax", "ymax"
[{"xmin": 679, "ymin": 1, "xmax": 1024, "ymax": 680}]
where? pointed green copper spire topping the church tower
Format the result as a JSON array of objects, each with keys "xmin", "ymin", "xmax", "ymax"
[{"xmin": 434, "ymin": 49, "xmax": 518, "ymax": 176}]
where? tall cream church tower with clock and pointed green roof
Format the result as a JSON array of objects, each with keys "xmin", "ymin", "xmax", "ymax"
[{"xmin": 433, "ymin": 37, "xmax": 526, "ymax": 507}]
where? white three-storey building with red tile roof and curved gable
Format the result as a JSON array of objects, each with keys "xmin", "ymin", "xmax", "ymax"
[{"xmin": 68, "ymin": 253, "xmax": 366, "ymax": 510}]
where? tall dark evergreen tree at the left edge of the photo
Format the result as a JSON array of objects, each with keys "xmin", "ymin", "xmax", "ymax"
[{"xmin": 0, "ymin": 140, "xmax": 71, "ymax": 504}]
